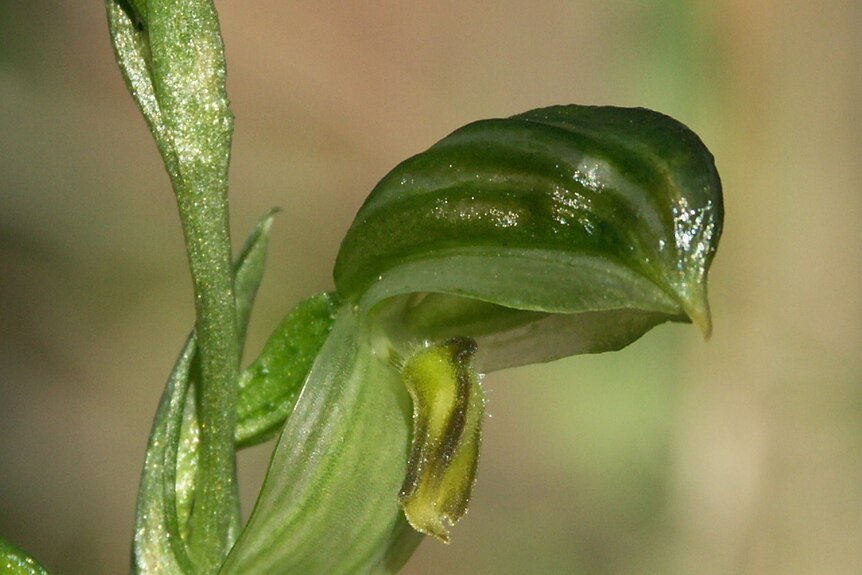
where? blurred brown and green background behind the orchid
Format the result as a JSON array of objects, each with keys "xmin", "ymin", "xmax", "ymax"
[{"xmin": 0, "ymin": 0, "xmax": 862, "ymax": 575}]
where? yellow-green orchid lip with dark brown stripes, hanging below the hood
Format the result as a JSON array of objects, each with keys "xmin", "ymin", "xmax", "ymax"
[{"xmin": 400, "ymin": 338, "xmax": 485, "ymax": 543}]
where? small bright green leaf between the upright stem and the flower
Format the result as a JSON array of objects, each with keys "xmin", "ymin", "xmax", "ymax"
[{"xmin": 236, "ymin": 293, "xmax": 346, "ymax": 447}]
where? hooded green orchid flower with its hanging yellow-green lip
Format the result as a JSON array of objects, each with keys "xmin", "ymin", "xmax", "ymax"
[{"xmin": 216, "ymin": 106, "xmax": 723, "ymax": 573}]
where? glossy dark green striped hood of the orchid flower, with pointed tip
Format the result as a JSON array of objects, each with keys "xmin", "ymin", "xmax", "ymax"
[{"xmin": 335, "ymin": 106, "xmax": 723, "ymax": 372}]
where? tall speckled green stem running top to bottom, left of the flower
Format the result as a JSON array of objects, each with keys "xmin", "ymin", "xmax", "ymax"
[{"xmin": 108, "ymin": 0, "xmax": 240, "ymax": 573}]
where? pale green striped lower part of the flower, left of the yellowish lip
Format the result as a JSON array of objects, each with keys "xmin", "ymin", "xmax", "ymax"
[{"xmin": 220, "ymin": 306, "xmax": 419, "ymax": 575}]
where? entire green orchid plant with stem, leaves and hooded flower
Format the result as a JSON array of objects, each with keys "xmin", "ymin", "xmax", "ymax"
[{"xmin": 104, "ymin": 0, "xmax": 723, "ymax": 575}]
